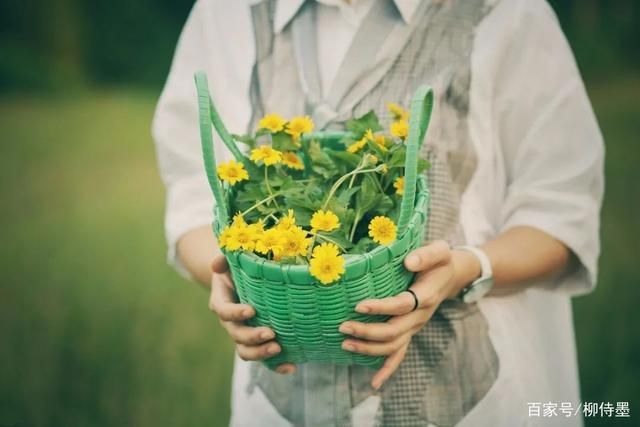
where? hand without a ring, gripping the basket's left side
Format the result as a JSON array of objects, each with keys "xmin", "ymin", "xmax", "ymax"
[{"xmin": 209, "ymin": 254, "xmax": 296, "ymax": 374}]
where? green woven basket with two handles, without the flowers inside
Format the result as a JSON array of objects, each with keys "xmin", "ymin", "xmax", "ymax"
[{"xmin": 195, "ymin": 72, "xmax": 433, "ymax": 369}]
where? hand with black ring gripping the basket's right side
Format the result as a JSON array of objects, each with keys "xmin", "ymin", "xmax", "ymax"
[{"xmin": 340, "ymin": 241, "xmax": 480, "ymax": 389}]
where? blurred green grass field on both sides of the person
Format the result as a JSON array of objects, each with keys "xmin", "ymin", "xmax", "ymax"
[{"xmin": 0, "ymin": 78, "xmax": 640, "ymax": 426}]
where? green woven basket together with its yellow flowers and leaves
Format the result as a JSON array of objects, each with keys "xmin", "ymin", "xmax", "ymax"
[{"xmin": 196, "ymin": 73, "xmax": 432, "ymax": 367}]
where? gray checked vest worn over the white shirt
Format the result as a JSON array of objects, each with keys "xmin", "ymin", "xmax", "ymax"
[{"xmin": 249, "ymin": 0, "xmax": 498, "ymax": 427}]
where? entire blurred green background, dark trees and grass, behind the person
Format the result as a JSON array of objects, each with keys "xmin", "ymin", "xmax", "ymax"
[{"xmin": 0, "ymin": 0, "xmax": 640, "ymax": 427}]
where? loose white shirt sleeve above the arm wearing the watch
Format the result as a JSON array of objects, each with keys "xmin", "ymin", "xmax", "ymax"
[{"xmin": 496, "ymin": 0, "xmax": 604, "ymax": 294}]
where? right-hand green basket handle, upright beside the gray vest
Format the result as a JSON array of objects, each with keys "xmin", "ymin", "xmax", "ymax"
[{"xmin": 398, "ymin": 85, "xmax": 433, "ymax": 236}]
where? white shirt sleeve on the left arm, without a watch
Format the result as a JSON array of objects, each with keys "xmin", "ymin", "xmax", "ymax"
[{"xmin": 152, "ymin": 0, "xmax": 248, "ymax": 278}]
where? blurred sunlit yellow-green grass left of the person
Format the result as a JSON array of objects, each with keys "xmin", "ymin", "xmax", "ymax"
[{"xmin": 0, "ymin": 93, "xmax": 232, "ymax": 426}]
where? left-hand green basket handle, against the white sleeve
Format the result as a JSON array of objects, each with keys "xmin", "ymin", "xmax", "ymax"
[{"xmin": 194, "ymin": 71, "xmax": 238, "ymax": 224}]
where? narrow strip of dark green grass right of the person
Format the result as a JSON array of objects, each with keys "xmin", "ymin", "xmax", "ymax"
[{"xmin": 574, "ymin": 77, "xmax": 640, "ymax": 426}]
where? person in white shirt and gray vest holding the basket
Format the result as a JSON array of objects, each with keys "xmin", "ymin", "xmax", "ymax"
[{"xmin": 153, "ymin": 0, "xmax": 604, "ymax": 427}]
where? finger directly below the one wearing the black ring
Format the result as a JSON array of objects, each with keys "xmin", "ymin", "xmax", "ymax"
[{"xmin": 339, "ymin": 312, "xmax": 424, "ymax": 342}]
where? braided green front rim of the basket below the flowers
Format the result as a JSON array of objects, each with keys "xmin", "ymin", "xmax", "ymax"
[{"xmin": 222, "ymin": 175, "xmax": 430, "ymax": 288}]
